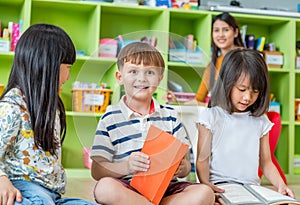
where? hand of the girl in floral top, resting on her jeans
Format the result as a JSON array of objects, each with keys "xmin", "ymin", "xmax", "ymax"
[{"xmin": 0, "ymin": 176, "xmax": 22, "ymax": 205}]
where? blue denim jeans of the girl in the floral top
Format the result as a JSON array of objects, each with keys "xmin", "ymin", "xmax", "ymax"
[{"xmin": 12, "ymin": 180, "xmax": 96, "ymax": 205}]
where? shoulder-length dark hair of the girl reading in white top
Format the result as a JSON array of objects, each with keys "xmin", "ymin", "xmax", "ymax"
[{"xmin": 209, "ymin": 48, "xmax": 270, "ymax": 116}]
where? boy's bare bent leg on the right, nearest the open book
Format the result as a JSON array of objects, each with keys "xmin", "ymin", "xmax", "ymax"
[{"xmin": 160, "ymin": 184, "xmax": 215, "ymax": 205}]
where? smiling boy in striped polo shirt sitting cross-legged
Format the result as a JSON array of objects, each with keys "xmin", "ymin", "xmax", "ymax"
[{"xmin": 91, "ymin": 42, "xmax": 214, "ymax": 205}]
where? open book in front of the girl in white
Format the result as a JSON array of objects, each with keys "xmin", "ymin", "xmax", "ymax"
[{"xmin": 217, "ymin": 183, "xmax": 300, "ymax": 205}]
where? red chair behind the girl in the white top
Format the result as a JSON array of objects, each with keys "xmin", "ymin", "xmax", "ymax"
[{"xmin": 258, "ymin": 111, "xmax": 287, "ymax": 184}]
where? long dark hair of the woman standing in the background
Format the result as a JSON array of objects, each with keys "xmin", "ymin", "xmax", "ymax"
[{"xmin": 209, "ymin": 12, "xmax": 244, "ymax": 89}]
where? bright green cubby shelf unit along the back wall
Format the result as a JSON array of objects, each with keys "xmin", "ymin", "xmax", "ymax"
[{"xmin": 0, "ymin": 0, "xmax": 300, "ymax": 182}]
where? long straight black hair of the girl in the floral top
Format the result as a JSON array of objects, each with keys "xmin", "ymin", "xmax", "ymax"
[{"xmin": 2, "ymin": 24, "xmax": 76, "ymax": 154}]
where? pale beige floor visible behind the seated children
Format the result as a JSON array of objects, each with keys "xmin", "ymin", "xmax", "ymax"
[{"xmin": 63, "ymin": 170, "xmax": 300, "ymax": 201}]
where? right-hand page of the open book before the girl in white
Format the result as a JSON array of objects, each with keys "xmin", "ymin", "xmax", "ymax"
[{"xmin": 249, "ymin": 185, "xmax": 297, "ymax": 203}]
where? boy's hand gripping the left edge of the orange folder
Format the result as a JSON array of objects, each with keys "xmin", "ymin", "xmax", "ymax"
[{"xmin": 128, "ymin": 152, "xmax": 150, "ymax": 174}]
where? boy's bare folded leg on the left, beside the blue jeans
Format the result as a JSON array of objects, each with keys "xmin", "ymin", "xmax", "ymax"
[{"xmin": 94, "ymin": 177, "xmax": 153, "ymax": 205}]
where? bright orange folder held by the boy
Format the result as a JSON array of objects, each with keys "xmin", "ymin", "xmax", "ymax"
[{"xmin": 130, "ymin": 125, "xmax": 189, "ymax": 205}]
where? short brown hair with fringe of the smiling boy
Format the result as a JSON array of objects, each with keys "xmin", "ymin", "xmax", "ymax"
[{"xmin": 117, "ymin": 42, "xmax": 165, "ymax": 73}]
